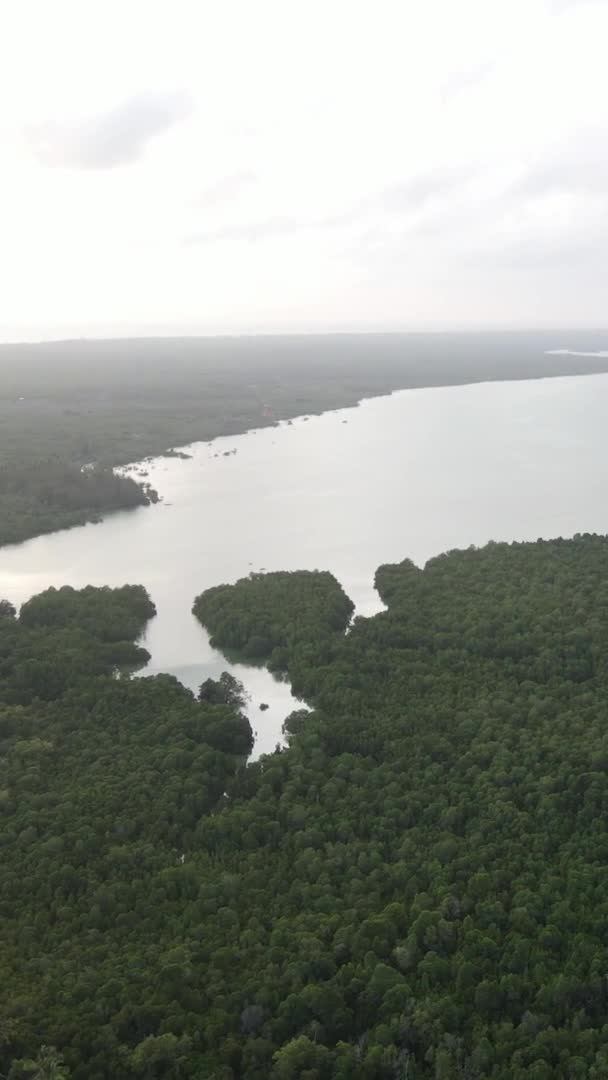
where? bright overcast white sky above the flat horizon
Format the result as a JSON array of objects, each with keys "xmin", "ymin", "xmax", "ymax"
[{"xmin": 0, "ymin": 0, "xmax": 608, "ymax": 340}]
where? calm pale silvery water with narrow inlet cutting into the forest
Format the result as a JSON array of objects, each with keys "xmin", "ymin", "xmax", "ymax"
[{"xmin": 0, "ymin": 375, "xmax": 608, "ymax": 754}]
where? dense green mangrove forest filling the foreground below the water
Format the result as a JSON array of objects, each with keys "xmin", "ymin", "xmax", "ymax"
[{"xmin": 0, "ymin": 535, "xmax": 608, "ymax": 1080}]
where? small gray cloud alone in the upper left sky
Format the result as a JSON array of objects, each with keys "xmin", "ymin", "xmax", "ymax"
[{"xmin": 28, "ymin": 93, "xmax": 192, "ymax": 168}]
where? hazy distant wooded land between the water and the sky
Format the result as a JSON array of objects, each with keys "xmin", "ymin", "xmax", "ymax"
[{"xmin": 0, "ymin": 329, "xmax": 608, "ymax": 544}]
